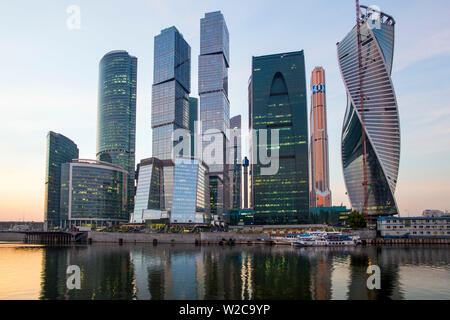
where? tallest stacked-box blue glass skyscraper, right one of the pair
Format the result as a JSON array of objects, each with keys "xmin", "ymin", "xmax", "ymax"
[{"xmin": 198, "ymin": 11, "xmax": 231, "ymax": 215}]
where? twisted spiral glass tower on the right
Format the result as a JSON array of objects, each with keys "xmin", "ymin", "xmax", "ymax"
[{"xmin": 337, "ymin": 6, "xmax": 400, "ymax": 222}]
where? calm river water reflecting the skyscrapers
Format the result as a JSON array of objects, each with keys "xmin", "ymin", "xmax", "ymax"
[{"xmin": 0, "ymin": 242, "xmax": 450, "ymax": 300}]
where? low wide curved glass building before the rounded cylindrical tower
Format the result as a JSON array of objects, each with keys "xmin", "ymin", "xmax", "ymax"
[{"xmin": 60, "ymin": 160, "xmax": 129, "ymax": 228}]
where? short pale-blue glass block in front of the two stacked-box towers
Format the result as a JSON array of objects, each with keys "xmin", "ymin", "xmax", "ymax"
[{"xmin": 170, "ymin": 158, "xmax": 209, "ymax": 223}]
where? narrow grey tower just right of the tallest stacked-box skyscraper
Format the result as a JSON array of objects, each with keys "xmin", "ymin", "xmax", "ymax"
[{"xmin": 228, "ymin": 115, "xmax": 242, "ymax": 209}]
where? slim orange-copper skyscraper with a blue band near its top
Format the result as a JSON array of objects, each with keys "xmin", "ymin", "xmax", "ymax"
[{"xmin": 310, "ymin": 67, "xmax": 331, "ymax": 207}]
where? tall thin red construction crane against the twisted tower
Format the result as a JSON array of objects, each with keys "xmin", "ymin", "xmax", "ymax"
[{"xmin": 355, "ymin": 0, "xmax": 369, "ymax": 220}]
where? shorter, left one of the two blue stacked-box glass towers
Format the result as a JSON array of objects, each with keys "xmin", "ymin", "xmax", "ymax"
[{"xmin": 152, "ymin": 27, "xmax": 191, "ymax": 214}]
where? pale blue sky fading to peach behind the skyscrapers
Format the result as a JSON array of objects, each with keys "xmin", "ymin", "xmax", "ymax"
[{"xmin": 0, "ymin": 0, "xmax": 450, "ymax": 221}]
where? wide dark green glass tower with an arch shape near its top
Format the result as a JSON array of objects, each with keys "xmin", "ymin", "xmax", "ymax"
[{"xmin": 249, "ymin": 51, "xmax": 309, "ymax": 224}]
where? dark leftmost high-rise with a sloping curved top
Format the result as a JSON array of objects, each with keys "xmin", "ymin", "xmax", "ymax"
[{"xmin": 44, "ymin": 131, "xmax": 79, "ymax": 228}]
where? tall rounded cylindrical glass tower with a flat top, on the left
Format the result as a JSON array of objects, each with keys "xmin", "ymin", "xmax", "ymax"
[{"xmin": 97, "ymin": 50, "xmax": 137, "ymax": 213}]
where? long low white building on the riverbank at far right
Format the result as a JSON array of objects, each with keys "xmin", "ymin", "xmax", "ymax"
[{"xmin": 377, "ymin": 217, "xmax": 450, "ymax": 238}]
